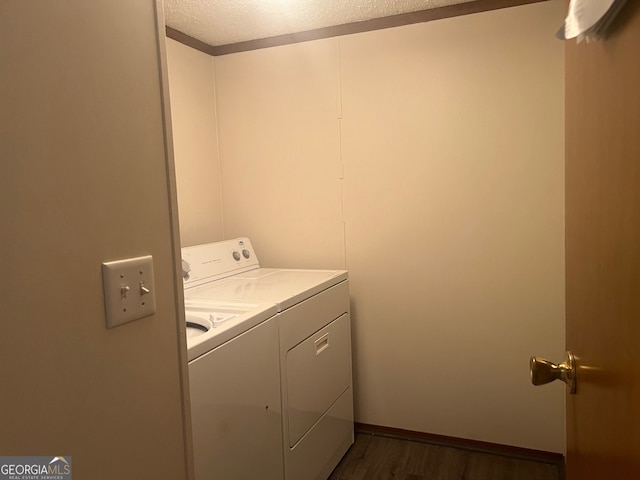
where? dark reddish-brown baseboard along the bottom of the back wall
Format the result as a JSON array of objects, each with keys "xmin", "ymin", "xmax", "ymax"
[{"xmin": 354, "ymin": 423, "xmax": 564, "ymax": 471}]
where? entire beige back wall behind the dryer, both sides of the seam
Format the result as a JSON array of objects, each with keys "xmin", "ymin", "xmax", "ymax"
[{"xmin": 171, "ymin": 2, "xmax": 564, "ymax": 452}]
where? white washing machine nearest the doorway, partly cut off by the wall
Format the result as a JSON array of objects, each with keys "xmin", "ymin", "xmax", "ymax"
[{"xmin": 185, "ymin": 288, "xmax": 284, "ymax": 480}]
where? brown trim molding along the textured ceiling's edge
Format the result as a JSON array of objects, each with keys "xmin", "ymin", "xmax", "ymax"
[{"xmin": 166, "ymin": 0, "xmax": 550, "ymax": 56}]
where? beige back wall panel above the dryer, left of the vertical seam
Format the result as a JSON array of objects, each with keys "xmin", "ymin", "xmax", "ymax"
[{"xmin": 215, "ymin": 39, "xmax": 345, "ymax": 268}]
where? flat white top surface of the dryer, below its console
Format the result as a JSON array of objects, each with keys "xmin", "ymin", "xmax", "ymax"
[{"xmin": 185, "ymin": 268, "xmax": 348, "ymax": 311}]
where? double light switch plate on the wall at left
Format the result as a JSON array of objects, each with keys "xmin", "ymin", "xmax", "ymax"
[{"xmin": 102, "ymin": 255, "xmax": 156, "ymax": 328}]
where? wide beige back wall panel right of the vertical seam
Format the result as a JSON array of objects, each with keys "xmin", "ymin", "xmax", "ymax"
[{"xmin": 340, "ymin": 2, "xmax": 564, "ymax": 452}]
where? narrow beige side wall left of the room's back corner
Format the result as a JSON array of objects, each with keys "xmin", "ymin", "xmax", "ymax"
[{"xmin": 167, "ymin": 39, "xmax": 223, "ymax": 246}]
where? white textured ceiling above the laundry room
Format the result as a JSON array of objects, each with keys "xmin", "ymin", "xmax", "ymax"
[{"xmin": 164, "ymin": 0, "xmax": 473, "ymax": 46}]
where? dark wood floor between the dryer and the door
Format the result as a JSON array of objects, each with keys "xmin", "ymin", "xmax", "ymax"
[{"xmin": 329, "ymin": 433, "xmax": 564, "ymax": 480}]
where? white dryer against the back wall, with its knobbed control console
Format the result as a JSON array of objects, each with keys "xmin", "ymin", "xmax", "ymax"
[{"xmin": 182, "ymin": 238, "xmax": 353, "ymax": 480}]
